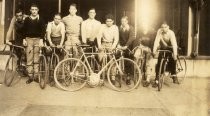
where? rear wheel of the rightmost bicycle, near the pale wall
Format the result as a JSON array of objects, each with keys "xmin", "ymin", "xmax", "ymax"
[{"xmin": 176, "ymin": 56, "xmax": 187, "ymax": 83}]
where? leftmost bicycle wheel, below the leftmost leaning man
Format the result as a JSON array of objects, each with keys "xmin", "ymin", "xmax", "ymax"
[{"xmin": 4, "ymin": 54, "xmax": 18, "ymax": 87}]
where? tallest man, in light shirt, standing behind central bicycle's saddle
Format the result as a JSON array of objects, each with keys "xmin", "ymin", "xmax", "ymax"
[{"xmin": 63, "ymin": 4, "xmax": 83, "ymax": 57}]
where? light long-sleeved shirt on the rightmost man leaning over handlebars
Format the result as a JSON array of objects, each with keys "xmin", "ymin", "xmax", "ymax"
[{"xmin": 153, "ymin": 29, "xmax": 177, "ymax": 55}]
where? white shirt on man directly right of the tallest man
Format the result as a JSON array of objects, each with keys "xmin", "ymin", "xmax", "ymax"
[{"xmin": 81, "ymin": 19, "xmax": 101, "ymax": 43}]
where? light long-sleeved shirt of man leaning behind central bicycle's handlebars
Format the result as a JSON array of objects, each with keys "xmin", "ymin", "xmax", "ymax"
[{"xmin": 97, "ymin": 24, "xmax": 119, "ymax": 47}]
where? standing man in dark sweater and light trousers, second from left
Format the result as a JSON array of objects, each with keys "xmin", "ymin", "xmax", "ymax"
[{"xmin": 23, "ymin": 4, "xmax": 45, "ymax": 84}]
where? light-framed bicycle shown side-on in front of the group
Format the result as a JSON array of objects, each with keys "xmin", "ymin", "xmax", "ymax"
[{"xmin": 54, "ymin": 45, "xmax": 140, "ymax": 91}]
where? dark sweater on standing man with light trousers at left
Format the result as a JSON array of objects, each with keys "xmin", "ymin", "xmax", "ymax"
[{"xmin": 23, "ymin": 17, "xmax": 45, "ymax": 39}]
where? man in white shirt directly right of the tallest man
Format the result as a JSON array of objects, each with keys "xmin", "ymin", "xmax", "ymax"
[{"xmin": 81, "ymin": 8, "xmax": 101, "ymax": 47}]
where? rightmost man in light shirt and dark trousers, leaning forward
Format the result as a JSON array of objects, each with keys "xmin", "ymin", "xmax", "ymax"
[{"xmin": 153, "ymin": 22, "xmax": 178, "ymax": 87}]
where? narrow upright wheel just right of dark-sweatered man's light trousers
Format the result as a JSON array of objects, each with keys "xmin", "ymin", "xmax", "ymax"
[{"xmin": 38, "ymin": 55, "xmax": 48, "ymax": 89}]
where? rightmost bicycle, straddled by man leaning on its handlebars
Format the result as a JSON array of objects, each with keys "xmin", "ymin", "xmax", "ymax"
[{"xmin": 156, "ymin": 50, "xmax": 187, "ymax": 91}]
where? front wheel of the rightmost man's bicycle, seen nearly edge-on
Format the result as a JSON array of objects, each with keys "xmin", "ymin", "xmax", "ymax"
[{"xmin": 158, "ymin": 59, "xmax": 167, "ymax": 91}]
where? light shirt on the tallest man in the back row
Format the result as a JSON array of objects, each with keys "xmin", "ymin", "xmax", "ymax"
[{"xmin": 63, "ymin": 15, "xmax": 83, "ymax": 37}]
